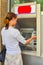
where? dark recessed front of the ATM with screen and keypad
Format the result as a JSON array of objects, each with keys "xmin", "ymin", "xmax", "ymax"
[{"xmin": 18, "ymin": 18, "xmax": 37, "ymax": 51}]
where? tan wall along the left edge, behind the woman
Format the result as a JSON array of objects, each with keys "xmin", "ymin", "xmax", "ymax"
[{"xmin": 0, "ymin": 0, "xmax": 8, "ymax": 65}]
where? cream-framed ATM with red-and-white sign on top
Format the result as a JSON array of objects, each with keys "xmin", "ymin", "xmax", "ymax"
[{"xmin": 11, "ymin": 2, "xmax": 41, "ymax": 56}]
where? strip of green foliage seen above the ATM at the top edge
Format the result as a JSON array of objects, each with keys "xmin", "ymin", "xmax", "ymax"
[{"xmin": 11, "ymin": 0, "xmax": 43, "ymax": 11}]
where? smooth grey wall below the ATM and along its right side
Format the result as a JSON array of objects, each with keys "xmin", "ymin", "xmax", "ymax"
[{"xmin": 23, "ymin": 15, "xmax": 43, "ymax": 65}]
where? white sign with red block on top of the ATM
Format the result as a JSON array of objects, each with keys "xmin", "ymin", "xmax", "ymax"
[{"xmin": 14, "ymin": 5, "xmax": 36, "ymax": 14}]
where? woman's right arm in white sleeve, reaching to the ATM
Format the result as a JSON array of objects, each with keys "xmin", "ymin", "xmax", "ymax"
[{"xmin": 13, "ymin": 29, "xmax": 36, "ymax": 44}]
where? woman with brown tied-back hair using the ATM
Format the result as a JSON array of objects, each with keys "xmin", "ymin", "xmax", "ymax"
[{"xmin": 1, "ymin": 12, "xmax": 36, "ymax": 65}]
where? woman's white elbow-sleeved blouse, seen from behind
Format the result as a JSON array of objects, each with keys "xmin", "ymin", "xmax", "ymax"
[{"xmin": 1, "ymin": 27, "xmax": 26, "ymax": 55}]
